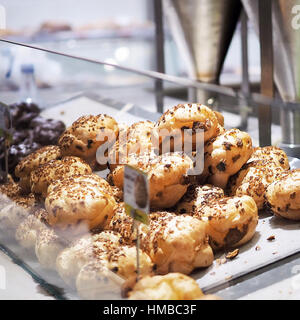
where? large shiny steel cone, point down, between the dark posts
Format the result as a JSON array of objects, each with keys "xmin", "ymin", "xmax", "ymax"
[{"xmin": 164, "ymin": 0, "xmax": 242, "ymax": 103}]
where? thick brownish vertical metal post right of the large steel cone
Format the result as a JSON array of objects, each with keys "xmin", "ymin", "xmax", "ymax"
[{"xmin": 258, "ymin": 0, "xmax": 274, "ymax": 147}]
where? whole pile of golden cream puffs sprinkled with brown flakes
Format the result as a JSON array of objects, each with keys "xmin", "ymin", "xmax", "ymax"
[{"xmin": 0, "ymin": 104, "xmax": 300, "ymax": 299}]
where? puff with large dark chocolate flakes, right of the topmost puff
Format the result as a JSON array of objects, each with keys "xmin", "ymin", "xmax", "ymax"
[{"xmin": 203, "ymin": 129, "xmax": 253, "ymax": 189}]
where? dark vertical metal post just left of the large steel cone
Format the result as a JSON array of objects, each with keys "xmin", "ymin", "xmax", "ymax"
[{"xmin": 154, "ymin": 0, "xmax": 165, "ymax": 113}]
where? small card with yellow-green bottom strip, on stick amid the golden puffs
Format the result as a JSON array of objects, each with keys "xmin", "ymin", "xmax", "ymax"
[{"xmin": 124, "ymin": 165, "xmax": 150, "ymax": 225}]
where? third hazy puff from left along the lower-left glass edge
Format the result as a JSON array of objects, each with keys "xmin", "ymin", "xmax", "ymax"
[{"xmin": 35, "ymin": 226, "xmax": 68, "ymax": 270}]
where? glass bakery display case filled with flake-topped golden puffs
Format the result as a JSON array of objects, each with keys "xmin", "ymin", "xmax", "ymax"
[{"xmin": 0, "ymin": 14, "xmax": 300, "ymax": 299}]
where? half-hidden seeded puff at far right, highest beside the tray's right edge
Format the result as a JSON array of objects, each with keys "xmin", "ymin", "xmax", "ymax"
[{"xmin": 249, "ymin": 146, "xmax": 290, "ymax": 170}]
